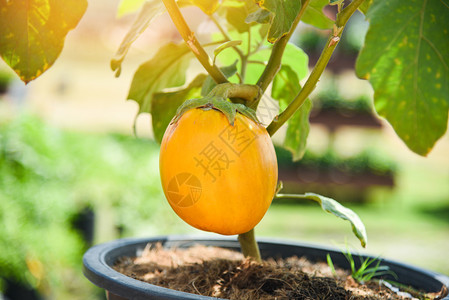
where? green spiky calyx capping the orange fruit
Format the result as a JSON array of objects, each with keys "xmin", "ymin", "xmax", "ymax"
[{"xmin": 171, "ymin": 96, "xmax": 260, "ymax": 126}]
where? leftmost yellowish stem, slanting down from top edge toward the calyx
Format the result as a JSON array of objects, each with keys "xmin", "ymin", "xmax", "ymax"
[{"xmin": 162, "ymin": 0, "xmax": 228, "ymax": 83}]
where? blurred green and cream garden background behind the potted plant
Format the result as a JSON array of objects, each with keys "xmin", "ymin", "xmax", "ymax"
[{"xmin": 0, "ymin": 0, "xmax": 449, "ymax": 300}]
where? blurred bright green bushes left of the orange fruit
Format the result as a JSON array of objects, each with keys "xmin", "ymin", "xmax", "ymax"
[{"xmin": 0, "ymin": 116, "xmax": 163, "ymax": 299}]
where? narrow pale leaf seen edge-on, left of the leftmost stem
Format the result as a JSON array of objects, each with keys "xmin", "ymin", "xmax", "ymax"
[{"xmin": 111, "ymin": 0, "xmax": 165, "ymax": 77}]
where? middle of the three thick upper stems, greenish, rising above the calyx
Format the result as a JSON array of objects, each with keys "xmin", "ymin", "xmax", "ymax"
[{"xmin": 251, "ymin": 0, "xmax": 310, "ymax": 109}]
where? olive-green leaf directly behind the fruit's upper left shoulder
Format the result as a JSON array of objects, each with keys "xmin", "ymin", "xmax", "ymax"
[{"xmin": 151, "ymin": 74, "xmax": 207, "ymax": 143}]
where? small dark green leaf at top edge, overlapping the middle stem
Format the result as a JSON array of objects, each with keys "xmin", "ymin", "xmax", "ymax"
[{"xmin": 255, "ymin": 0, "xmax": 301, "ymax": 43}]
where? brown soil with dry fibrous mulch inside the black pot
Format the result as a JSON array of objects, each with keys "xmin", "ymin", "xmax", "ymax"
[{"xmin": 114, "ymin": 245, "xmax": 444, "ymax": 300}]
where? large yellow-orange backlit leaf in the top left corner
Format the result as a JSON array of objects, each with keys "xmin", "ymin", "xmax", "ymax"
[{"xmin": 0, "ymin": 0, "xmax": 87, "ymax": 83}]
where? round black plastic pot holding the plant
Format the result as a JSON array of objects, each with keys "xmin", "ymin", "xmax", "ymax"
[{"xmin": 83, "ymin": 236, "xmax": 449, "ymax": 300}]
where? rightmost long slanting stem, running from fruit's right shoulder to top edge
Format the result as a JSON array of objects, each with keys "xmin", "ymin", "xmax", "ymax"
[{"xmin": 267, "ymin": 0, "xmax": 364, "ymax": 136}]
